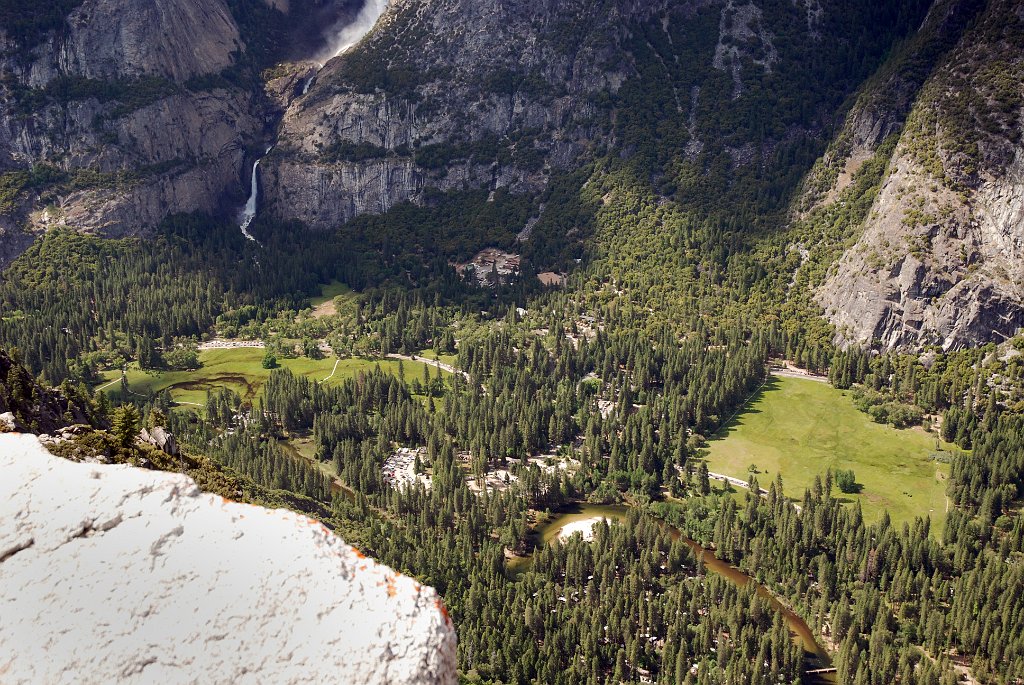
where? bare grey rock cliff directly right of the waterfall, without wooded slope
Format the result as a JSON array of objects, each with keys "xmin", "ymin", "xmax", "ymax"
[{"xmin": 262, "ymin": 0, "xmax": 667, "ymax": 228}]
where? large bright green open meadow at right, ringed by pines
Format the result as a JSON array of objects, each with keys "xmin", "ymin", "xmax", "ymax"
[{"xmin": 708, "ymin": 378, "xmax": 949, "ymax": 531}]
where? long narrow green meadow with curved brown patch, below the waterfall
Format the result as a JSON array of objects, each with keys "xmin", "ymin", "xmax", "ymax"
[{"xmin": 99, "ymin": 347, "xmax": 447, "ymax": 405}]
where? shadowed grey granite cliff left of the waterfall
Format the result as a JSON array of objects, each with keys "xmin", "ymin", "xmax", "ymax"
[{"xmin": 0, "ymin": 0, "xmax": 263, "ymax": 263}]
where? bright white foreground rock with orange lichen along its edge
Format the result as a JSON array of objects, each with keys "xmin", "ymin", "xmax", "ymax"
[{"xmin": 0, "ymin": 435, "xmax": 456, "ymax": 685}]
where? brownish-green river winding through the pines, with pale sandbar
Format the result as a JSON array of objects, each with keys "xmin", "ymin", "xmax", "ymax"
[{"xmin": 509, "ymin": 505, "xmax": 836, "ymax": 685}]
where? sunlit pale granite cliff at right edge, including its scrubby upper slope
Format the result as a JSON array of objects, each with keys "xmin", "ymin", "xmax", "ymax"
[{"xmin": 817, "ymin": 0, "xmax": 1024, "ymax": 349}]
